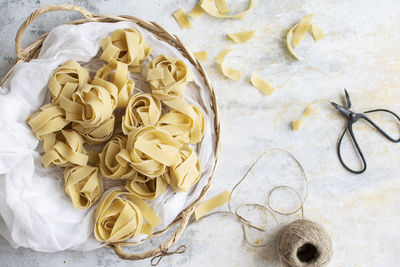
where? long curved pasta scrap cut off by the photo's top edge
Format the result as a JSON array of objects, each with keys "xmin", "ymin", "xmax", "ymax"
[{"xmin": 200, "ymin": 0, "xmax": 254, "ymax": 19}]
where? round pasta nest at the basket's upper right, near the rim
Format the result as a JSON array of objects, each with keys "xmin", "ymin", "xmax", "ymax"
[{"xmin": 146, "ymin": 55, "xmax": 193, "ymax": 100}]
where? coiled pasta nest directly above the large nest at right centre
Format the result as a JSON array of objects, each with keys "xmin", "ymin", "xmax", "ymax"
[{"xmin": 122, "ymin": 93, "xmax": 161, "ymax": 135}]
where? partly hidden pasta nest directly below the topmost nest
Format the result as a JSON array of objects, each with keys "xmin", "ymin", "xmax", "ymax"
[{"xmin": 92, "ymin": 61, "xmax": 135, "ymax": 108}]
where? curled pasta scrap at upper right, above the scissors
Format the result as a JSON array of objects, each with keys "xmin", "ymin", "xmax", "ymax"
[{"xmin": 286, "ymin": 14, "xmax": 325, "ymax": 60}]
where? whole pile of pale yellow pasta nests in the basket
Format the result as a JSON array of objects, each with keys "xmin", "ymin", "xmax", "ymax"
[{"xmin": 27, "ymin": 29, "xmax": 205, "ymax": 245}]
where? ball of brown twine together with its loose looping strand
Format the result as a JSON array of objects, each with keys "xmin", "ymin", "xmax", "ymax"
[{"xmin": 192, "ymin": 148, "xmax": 333, "ymax": 267}]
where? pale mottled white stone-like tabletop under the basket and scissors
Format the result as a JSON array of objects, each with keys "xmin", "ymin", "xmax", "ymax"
[{"xmin": 0, "ymin": 0, "xmax": 400, "ymax": 266}]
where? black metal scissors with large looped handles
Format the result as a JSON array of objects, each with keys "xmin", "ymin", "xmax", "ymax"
[{"xmin": 331, "ymin": 89, "xmax": 400, "ymax": 174}]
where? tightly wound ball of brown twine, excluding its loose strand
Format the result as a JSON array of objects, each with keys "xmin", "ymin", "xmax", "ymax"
[{"xmin": 276, "ymin": 220, "xmax": 333, "ymax": 267}]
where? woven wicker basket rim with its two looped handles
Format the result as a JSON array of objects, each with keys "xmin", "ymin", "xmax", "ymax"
[{"xmin": 0, "ymin": 5, "xmax": 220, "ymax": 260}]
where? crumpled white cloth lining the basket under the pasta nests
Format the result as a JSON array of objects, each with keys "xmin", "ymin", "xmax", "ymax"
[{"xmin": 0, "ymin": 22, "xmax": 216, "ymax": 252}]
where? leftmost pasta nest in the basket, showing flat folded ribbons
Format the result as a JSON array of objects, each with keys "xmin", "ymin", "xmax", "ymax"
[{"xmin": 27, "ymin": 103, "xmax": 70, "ymax": 139}]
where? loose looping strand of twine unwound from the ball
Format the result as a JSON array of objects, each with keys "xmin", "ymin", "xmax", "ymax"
[{"xmin": 198, "ymin": 148, "xmax": 308, "ymax": 247}]
